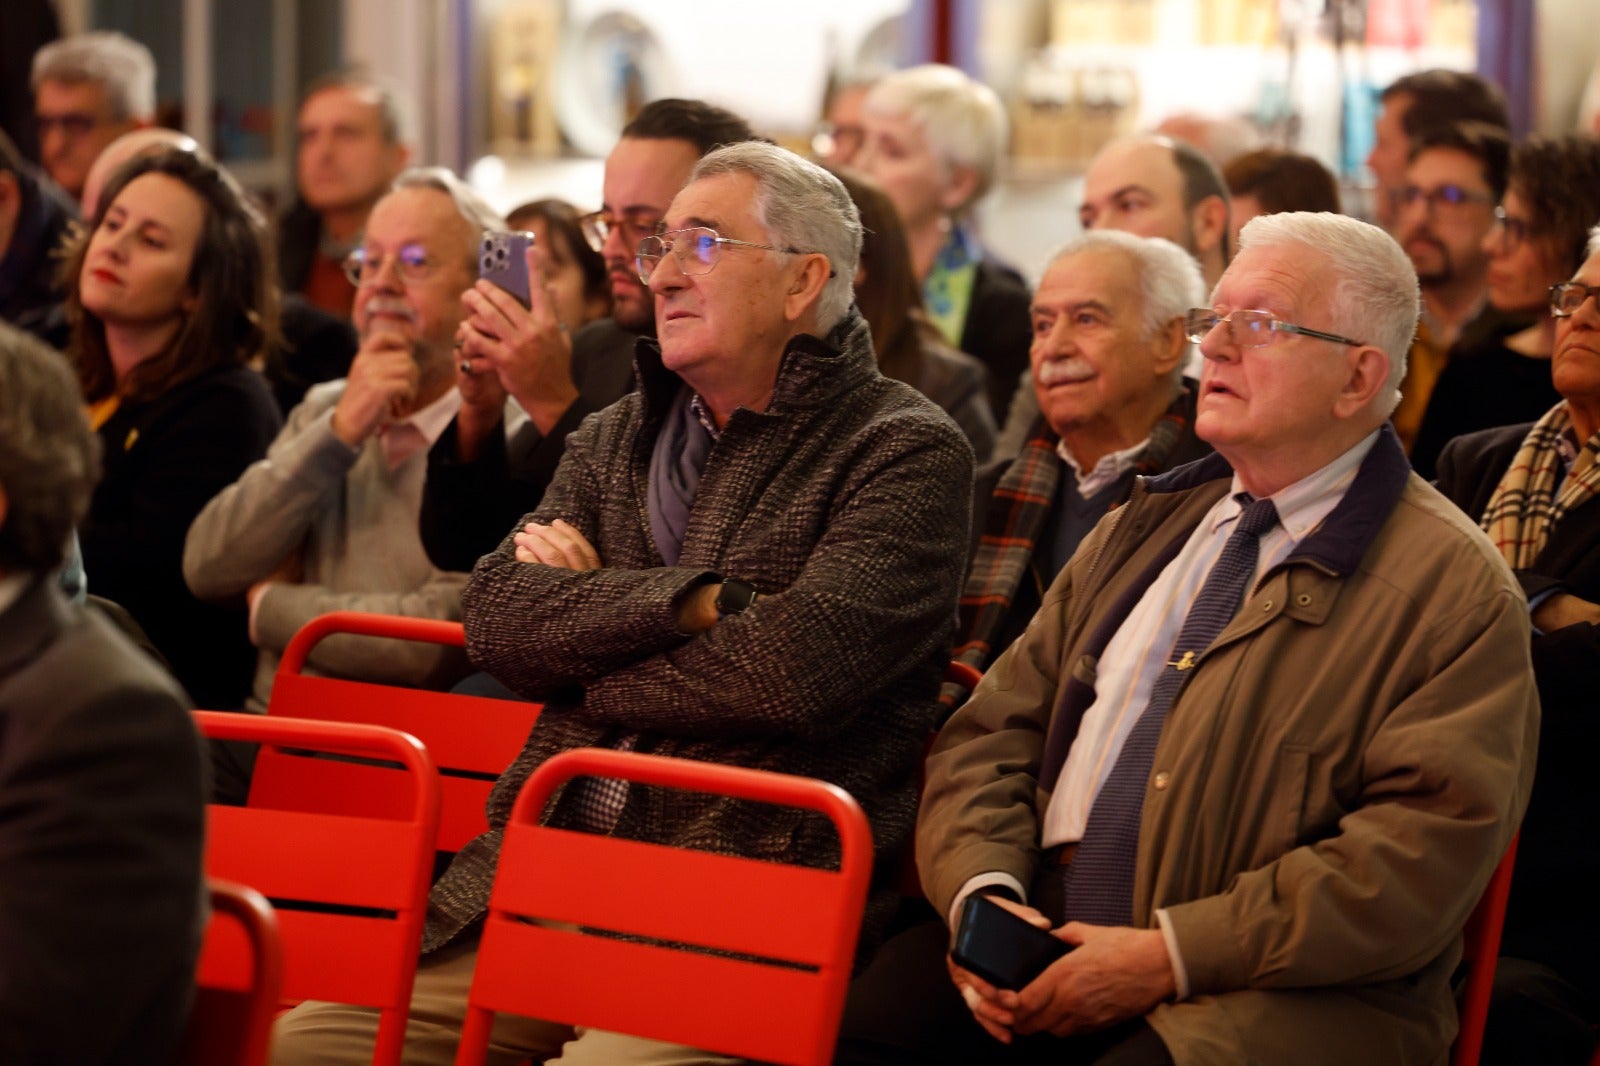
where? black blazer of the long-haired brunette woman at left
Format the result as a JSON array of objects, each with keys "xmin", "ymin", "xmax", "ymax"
[{"xmin": 78, "ymin": 367, "xmax": 283, "ymax": 711}]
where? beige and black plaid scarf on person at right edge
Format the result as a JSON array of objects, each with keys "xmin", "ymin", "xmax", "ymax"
[{"xmin": 1478, "ymin": 400, "xmax": 1600, "ymax": 570}]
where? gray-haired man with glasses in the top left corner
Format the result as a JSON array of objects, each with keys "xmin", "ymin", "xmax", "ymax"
[{"xmin": 34, "ymin": 30, "xmax": 155, "ymax": 198}]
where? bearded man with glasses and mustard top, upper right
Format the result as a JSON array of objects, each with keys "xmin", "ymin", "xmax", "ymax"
[{"xmin": 1394, "ymin": 122, "xmax": 1510, "ymax": 451}]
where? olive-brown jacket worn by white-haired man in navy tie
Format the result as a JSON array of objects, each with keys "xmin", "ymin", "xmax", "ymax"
[{"xmin": 917, "ymin": 427, "xmax": 1538, "ymax": 1066}]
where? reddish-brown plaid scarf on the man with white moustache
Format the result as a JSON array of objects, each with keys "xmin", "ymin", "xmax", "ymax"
[{"xmin": 955, "ymin": 389, "xmax": 1189, "ymax": 669}]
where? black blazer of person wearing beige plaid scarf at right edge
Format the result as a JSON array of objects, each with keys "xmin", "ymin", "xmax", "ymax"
[{"xmin": 1437, "ymin": 424, "xmax": 1600, "ymax": 996}]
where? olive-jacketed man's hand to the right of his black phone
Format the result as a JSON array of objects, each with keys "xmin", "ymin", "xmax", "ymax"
[{"xmin": 1011, "ymin": 922, "xmax": 1176, "ymax": 1036}]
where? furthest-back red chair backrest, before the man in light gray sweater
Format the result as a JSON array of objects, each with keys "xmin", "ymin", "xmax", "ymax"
[{"xmin": 251, "ymin": 611, "xmax": 541, "ymax": 852}]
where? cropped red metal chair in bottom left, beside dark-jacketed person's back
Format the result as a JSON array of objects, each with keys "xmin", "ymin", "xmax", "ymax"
[{"xmin": 178, "ymin": 880, "xmax": 283, "ymax": 1066}]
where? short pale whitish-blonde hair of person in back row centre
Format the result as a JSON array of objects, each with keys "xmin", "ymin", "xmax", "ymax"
[{"xmin": 866, "ymin": 62, "xmax": 1010, "ymax": 211}]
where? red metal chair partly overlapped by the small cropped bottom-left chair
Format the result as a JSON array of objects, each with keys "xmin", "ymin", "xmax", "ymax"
[{"xmin": 194, "ymin": 711, "xmax": 438, "ymax": 1064}]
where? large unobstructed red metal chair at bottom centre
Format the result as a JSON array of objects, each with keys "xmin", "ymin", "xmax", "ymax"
[{"xmin": 456, "ymin": 747, "xmax": 872, "ymax": 1066}]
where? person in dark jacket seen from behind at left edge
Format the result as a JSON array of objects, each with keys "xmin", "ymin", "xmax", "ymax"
[{"xmin": 0, "ymin": 325, "xmax": 205, "ymax": 1066}]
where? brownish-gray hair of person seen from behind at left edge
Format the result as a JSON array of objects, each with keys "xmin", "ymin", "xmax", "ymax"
[{"xmin": 0, "ymin": 322, "xmax": 99, "ymax": 573}]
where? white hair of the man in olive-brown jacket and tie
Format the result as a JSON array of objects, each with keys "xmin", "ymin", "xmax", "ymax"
[{"xmin": 1238, "ymin": 211, "xmax": 1422, "ymax": 413}]
